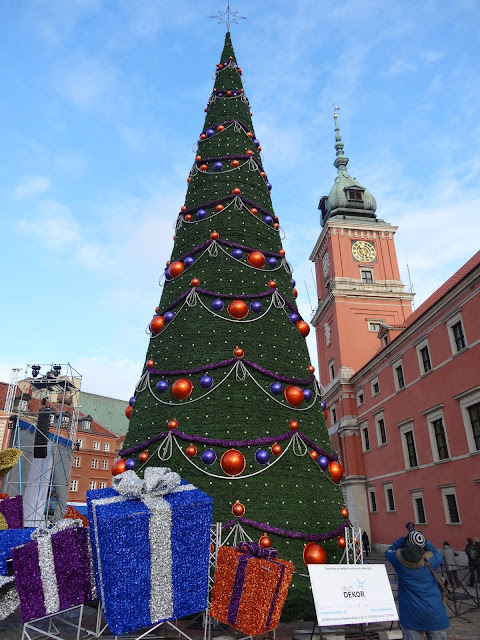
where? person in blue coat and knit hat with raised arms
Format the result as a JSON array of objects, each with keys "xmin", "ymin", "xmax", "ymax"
[{"xmin": 385, "ymin": 531, "xmax": 450, "ymax": 640}]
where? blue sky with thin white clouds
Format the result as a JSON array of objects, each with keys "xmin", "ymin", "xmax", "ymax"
[{"xmin": 0, "ymin": 0, "xmax": 480, "ymax": 399}]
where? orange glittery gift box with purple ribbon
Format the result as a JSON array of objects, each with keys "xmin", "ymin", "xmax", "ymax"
[{"xmin": 209, "ymin": 547, "xmax": 294, "ymax": 636}]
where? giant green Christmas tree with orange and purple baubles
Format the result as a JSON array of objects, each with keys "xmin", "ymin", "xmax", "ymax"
[{"xmin": 123, "ymin": 32, "xmax": 348, "ymax": 617}]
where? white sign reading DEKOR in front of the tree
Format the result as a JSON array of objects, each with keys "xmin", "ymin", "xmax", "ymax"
[{"xmin": 308, "ymin": 564, "xmax": 398, "ymax": 626}]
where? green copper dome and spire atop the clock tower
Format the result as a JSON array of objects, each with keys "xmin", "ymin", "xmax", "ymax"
[{"xmin": 318, "ymin": 114, "xmax": 377, "ymax": 226}]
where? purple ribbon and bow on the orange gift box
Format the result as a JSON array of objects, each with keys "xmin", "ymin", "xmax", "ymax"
[{"xmin": 227, "ymin": 542, "xmax": 285, "ymax": 629}]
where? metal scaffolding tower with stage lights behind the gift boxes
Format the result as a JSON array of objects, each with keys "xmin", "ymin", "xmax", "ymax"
[{"xmin": 1, "ymin": 364, "xmax": 82, "ymax": 527}]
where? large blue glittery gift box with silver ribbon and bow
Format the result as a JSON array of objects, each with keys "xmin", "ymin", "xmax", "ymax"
[{"xmin": 87, "ymin": 467, "xmax": 213, "ymax": 634}]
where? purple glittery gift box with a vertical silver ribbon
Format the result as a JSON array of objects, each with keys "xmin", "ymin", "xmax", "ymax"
[{"xmin": 12, "ymin": 526, "xmax": 92, "ymax": 622}]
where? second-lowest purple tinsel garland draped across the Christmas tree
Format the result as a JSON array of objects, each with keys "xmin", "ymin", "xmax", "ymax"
[{"xmin": 118, "ymin": 430, "xmax": 338, "ymax": 462}]
